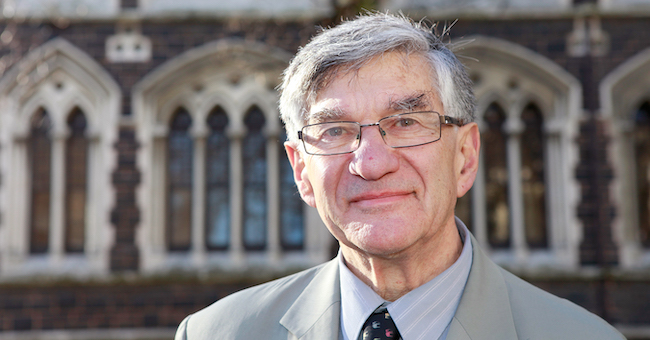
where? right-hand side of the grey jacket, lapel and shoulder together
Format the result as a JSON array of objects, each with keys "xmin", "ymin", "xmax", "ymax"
[{"xmin": 460, "ymin": 236, "xmax": 625, "ymax": 340}]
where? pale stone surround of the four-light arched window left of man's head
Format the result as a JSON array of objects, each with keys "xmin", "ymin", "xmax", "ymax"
[{"xmin": 133, "ymin": 39, "xmax": 326, "ymax": 271}]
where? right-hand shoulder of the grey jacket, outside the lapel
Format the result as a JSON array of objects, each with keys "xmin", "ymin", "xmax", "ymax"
[{"xmin": 501, "ymin": 269, "xmax": 624, "ymax": 339}]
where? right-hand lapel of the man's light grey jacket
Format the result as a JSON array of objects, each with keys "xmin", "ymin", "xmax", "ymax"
[{"xmin": 447, "ymin": 236, "xmax": 517, "ymax": 340}]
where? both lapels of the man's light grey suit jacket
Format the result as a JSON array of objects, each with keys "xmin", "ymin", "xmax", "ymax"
[{"xmin": 280, "ymin": 236, "xmax": 517, "ymax": 340}]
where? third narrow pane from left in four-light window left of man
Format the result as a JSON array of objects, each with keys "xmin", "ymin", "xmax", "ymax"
[{"xmin": 242, "ymin": 107, "xmax": 267, "ymax": 250}]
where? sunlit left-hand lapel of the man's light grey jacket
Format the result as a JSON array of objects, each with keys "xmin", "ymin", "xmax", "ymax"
[{"xmin": 280, "ymin": 259, "xmax": 341, "ymax": 340}]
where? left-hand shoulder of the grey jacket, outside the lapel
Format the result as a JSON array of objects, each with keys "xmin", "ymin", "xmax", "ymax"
[{"xmin": 176, "ymin": 258, "xmax": 334, "ymax": 340}]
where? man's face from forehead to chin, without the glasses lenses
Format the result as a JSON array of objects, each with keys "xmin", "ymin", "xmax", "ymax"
[{"xmin": 287, "ymin": 52, "xmax": 471, "ymax": 256}]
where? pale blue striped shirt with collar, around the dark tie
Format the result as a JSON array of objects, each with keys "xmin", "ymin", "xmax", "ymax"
[{"xmin": 338, "ymin": 218, "xmax": 472, "ymax": 340}]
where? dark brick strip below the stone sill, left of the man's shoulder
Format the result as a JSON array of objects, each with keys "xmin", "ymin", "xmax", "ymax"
[{"xmin": 0, "ymin": 282, "xmax": 247, "ymax": 331}]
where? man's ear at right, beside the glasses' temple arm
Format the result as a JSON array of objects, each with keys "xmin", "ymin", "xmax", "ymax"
[{"xmin": 456, "ymin": 122, "xmax": 481, "ymax": 197}]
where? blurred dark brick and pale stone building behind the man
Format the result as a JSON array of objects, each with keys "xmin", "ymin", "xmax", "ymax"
[{"xmin": 0, "ymin": 0, "xmax": 650, "ymax": 339}]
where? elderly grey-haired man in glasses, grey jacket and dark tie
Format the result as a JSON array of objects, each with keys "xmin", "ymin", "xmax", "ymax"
[{"xmin": 176, "ymin": 14, "xmax": 623, "ymax": 340}]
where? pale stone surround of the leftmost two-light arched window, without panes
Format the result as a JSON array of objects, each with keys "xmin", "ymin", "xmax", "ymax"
[{"xmin": 0, "ymin": 38, "xmax": 121, "ymax": 275}]
